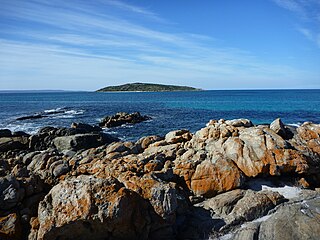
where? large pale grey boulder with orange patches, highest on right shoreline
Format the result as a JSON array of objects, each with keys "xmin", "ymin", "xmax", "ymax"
[{"xmin": 185, "ymin": 120, "xmax": 312, "ymax": 177}]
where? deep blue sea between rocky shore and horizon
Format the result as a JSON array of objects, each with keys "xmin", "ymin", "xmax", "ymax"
[{"xmin": 0, "ymin": 90, "xmax": 320, "ymax": 140}]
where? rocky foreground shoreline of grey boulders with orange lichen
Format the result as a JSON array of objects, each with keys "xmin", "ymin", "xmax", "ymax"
[{"xmin": 0, "ymin": 118, "xmax": 320, "ymax": 240}]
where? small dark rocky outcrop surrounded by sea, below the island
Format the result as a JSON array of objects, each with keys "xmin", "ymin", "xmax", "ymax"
[{"xmin": 99, "ymin": 112, "xmax": 151, "ymax": 128}]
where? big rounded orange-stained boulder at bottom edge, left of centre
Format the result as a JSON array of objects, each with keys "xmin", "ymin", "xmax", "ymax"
[{"xmin": 33, "ymin": 176, "xmax": 150, "ymax": 239}]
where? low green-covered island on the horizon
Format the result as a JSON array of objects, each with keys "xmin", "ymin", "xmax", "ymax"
[{"xmin": 97, "ymin": 83, "xmax": 201, "ymax": 92}]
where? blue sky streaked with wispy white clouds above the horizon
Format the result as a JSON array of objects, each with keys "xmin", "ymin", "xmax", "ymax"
[{"xmin": 0, "ymin": 0, "xmax": 320, "ymax": 90}]
